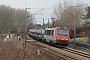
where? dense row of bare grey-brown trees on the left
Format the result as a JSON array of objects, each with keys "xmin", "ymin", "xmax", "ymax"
[{"xmin": 0, "ymin": 5, "xmax": 34, "ymax": 33}]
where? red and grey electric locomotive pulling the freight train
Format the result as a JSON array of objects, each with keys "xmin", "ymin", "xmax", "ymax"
[{"xmin": 44, "ymin": 26, "xmax": 70, "ymax": 46}]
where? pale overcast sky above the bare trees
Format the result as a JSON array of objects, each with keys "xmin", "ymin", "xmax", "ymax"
[{"xmin": 0, "ymin": 0, "xmax": 90, "ymax": 23}]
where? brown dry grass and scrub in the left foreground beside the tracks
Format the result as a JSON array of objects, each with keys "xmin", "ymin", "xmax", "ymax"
[{"xmin": 0, "ymin": 35, "xmax": 64, "ymax": 60}]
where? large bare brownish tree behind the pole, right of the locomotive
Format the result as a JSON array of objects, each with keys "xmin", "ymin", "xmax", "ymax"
[{"xmin": 54, "ymin": 1, "xmax": 84, "ymax": 29}]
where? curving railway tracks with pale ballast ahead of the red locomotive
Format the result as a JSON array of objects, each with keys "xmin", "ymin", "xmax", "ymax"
[{"xmin": 26, "ymin": 35, "xmax": 90, "ymax": 60}]
